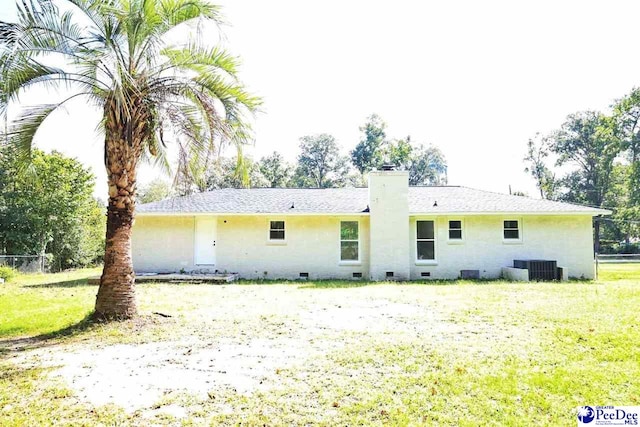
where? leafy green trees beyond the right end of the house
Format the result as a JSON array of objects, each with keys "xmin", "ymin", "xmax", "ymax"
[{"xmin": 524, "ymin": 88, "xmax": 640, "ymax": 253}]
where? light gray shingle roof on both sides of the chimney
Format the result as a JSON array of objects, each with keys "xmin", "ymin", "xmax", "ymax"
[{"xmin": 137, "ymin": 186, "xmax": 610, "ymax": 215}]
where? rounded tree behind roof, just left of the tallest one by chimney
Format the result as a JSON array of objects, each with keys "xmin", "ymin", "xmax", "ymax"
[{"xmin": 293, "ymin": 133, "xmax": 349, "ymax": 188}]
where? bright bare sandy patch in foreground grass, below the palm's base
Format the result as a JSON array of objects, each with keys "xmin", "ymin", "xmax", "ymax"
[{"xmin": 17, "ymin": 339, "xmax": 303, "ymax": 411}]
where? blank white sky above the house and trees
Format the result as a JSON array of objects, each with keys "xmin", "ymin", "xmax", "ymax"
[{"xmin": 0, "ymin": 0, "xmax": 640, "ymax": 198}]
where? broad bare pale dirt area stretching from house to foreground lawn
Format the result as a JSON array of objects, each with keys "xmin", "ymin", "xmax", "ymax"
[{"xmin": 5, "ymin": 285, "xmax": 532, "ymax": 418}]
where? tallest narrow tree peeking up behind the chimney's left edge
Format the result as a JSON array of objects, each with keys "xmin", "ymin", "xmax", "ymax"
[{"xmin": 350, "ymin": 114, "xmax": 387, "ymax": 174}]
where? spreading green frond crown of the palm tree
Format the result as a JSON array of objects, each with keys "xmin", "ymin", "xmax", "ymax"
[{"xmin": 0, "ymin": 0, "xmax": 261, "ymax": 192}]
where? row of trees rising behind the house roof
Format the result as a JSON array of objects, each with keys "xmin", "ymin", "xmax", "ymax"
[{"xmin": 139, "ymin": 114, "xmax": 447, "ymax": 203}]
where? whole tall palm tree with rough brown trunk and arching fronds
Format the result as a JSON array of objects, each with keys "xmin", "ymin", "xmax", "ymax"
[{"xmin": 0, "ymin": 0, "xmax": 260, "ymax": 318}]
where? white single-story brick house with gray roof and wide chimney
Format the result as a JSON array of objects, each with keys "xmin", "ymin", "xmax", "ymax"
[{"xmin": 132, "ymin": 171, "xmax": 610, "ymax": 280}]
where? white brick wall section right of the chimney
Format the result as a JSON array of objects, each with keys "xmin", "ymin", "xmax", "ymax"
[{"xmin": 410, "ymin": 215, "xmax": 594, "ymax": 280}]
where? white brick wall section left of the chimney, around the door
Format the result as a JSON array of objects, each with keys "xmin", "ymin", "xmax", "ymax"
[{"xmin": 132, "ymin": 215, "xmax": 369, "ymax": 279}]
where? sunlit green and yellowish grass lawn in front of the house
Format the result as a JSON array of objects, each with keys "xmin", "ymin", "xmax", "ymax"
[{"xmin": 0, "ymin": 264, "xmax": 640, "ymax": 426}]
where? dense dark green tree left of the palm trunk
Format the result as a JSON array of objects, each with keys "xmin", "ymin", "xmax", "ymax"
[{"xmin": 0, "ymin": 148, "xmax": 105, "ymax": 270}]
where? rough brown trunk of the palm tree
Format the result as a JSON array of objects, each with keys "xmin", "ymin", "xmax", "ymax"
[{"xmin": 94, "ymin": 111, "xmax": 142, "ymax": 319}]
